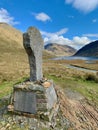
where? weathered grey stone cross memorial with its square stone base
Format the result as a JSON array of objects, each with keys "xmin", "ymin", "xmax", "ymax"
[{"xmin": 9, "ymin": 27, "xmax": 57, "ymax": 120}]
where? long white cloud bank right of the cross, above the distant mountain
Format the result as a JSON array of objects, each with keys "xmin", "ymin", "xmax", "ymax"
[{"xmin": 41, "ymin": 28, "xmax": 91, "ymax": 49}]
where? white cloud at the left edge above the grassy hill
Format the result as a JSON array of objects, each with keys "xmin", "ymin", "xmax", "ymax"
[{"xmin": 0, "ymin": 8, "xmax": 19, "ymax": 25}]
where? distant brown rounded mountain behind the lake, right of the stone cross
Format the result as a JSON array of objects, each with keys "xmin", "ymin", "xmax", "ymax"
[{"xmin": 44, "ymin": 43, "xmax": 76, "ymax": 56}]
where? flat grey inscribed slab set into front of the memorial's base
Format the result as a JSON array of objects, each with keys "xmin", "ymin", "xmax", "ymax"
[{"xmin": 14, "ymin": 91, "xmax": 37, "ymax": 114}]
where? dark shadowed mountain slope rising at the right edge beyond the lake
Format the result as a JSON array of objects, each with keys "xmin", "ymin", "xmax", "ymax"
[{"xmin": 75, "ymin": 40, "xmax": 98, "ymax": 57}]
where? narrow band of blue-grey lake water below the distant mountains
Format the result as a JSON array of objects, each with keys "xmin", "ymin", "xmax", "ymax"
[{"xmin": 53, "ymin": 56, "xmax": 98, "ymax": 61}]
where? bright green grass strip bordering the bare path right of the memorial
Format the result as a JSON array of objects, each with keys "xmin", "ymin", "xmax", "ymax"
[{"xmin": 48, "ymin": 75, "xmax": 98, "ymax": 107}]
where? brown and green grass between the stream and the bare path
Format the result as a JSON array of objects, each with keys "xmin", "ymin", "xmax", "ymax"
[{"xmin": 44, "ymin": 62, "xmax": 98, "ymax": 107}]
